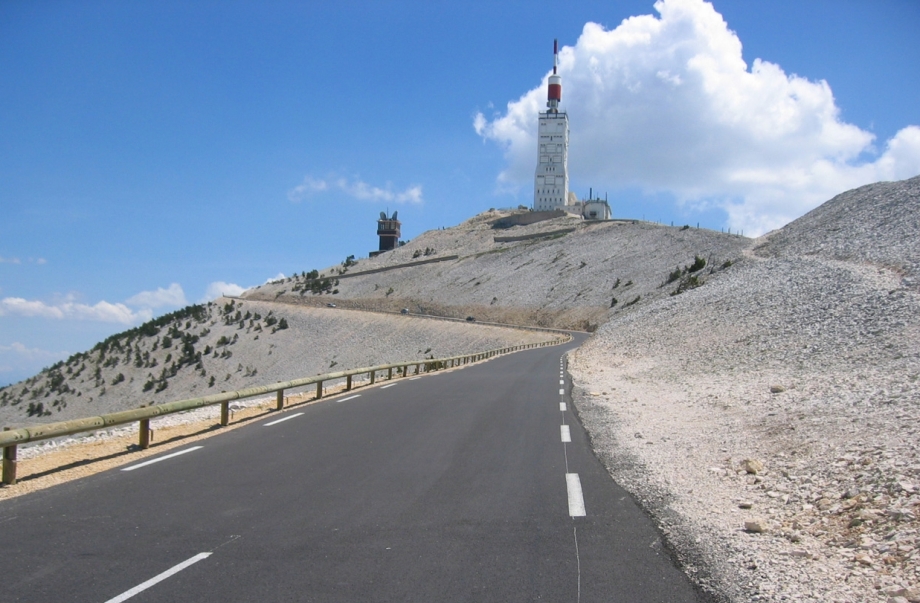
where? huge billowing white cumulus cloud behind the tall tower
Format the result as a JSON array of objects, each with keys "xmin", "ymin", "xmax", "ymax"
[{"xmin": 473, "ymin": 0, "xmax": 920, "ymax": 234}]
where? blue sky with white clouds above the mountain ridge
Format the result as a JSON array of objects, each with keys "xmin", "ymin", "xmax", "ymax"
[{"xmin": 0, "ymin": 0, "xmax": 920, "ymax": 384}]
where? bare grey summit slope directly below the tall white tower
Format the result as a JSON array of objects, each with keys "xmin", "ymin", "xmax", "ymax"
[{"xmin": 244, "ymin": 212, "xmax": 750, "ymax": 330}]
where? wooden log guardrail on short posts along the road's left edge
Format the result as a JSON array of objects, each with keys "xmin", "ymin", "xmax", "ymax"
[{"xmin": 0, "ymin": 335, "xmax": 572, "ymax": 485}]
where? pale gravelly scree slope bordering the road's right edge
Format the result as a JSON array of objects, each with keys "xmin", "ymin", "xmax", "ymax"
[{"xmin": 569, "ymin": 178, "xmax": 920, "ymax": 603}]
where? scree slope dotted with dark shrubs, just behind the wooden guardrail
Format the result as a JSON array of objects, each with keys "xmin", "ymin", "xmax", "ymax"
[{"xmin": 0, "ymin": 299, "xmax": 551, "ymax": 426}]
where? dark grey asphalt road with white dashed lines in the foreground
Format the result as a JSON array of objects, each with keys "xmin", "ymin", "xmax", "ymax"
[{"xmin": 0, "ymin": 336, "xmax": 702, "ymax": 603}]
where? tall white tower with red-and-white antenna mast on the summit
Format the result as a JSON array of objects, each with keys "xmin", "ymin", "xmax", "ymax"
[{"xmin": 533, "ymin": 40, "xmax": 569, "ymax": 211}]
